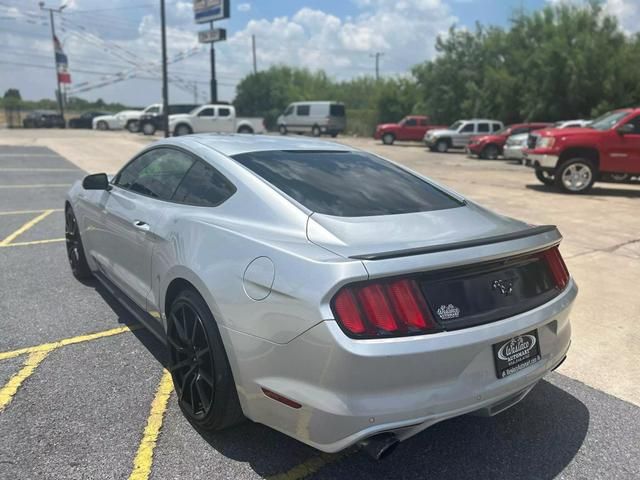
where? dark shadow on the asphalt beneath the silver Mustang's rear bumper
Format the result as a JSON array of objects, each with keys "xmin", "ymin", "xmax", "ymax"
[{"xmin": 192, "ymin": 381, "xmax": 589, "ymax": 480}]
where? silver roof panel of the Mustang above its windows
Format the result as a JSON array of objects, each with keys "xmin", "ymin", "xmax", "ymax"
[{"xmin": 168, "ymin": 133, "xmax": 357, "ymax": 156}]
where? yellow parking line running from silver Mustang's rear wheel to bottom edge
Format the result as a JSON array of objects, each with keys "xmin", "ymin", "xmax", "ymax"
[{"xmin": 129, "ymin": 370, "xmax": 173, "ymax": 480}]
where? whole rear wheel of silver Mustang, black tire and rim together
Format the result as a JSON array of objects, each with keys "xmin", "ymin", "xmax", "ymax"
[{"xmin": 167, "ymin": 289, "xmax": 244, "ymax": 432}]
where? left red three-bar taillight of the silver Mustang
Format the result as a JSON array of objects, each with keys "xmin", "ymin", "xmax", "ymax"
[{"xmin": 332, "ymin": 279, "xmax": 440, "ymax": 338}]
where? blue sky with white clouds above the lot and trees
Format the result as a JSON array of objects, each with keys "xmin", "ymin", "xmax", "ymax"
[{"xmin": 0, "ymin": 0, "xmax": 640, "ymax": 106}]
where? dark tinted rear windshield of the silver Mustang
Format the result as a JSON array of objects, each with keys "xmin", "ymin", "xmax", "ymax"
[{"xmin": 233, "ymin": 150, "xmax": 462, "ymax": 217}]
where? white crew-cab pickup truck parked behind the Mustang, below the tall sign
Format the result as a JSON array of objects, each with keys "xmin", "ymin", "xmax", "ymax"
[{"xmin": 169, "ymin": 104, "xmax": 265, "ymax": 136}]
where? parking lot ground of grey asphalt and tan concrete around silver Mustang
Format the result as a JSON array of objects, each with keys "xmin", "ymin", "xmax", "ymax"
[{"xmin": 0, "ymin": 136, "xmax": 640, "ymax": 480}]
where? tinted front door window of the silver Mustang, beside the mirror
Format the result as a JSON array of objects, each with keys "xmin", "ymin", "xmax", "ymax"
[{"xmin": 114, "ymin": 148, "xmax": 193, "ymax": 200}]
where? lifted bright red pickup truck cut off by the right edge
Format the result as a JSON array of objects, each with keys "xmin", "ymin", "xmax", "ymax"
[{"xmin": 524, "ymin": 108, "xmax": 640, "ymax": 193}]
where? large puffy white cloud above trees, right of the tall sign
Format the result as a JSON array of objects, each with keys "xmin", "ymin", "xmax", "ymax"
[{"xmin": 221, "ymin": 0, "xmax": 456, "ymax": 78}]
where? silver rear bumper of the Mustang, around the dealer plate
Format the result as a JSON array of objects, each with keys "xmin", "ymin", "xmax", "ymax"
[{"xmin": 224, "ymin": 280, "xmax": 577, "ymax": 452}]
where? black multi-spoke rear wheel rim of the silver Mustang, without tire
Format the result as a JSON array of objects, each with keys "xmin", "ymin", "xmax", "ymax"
[{"xmin": 167, "ymin": 301, "xmax": 216, "ymax": 419}]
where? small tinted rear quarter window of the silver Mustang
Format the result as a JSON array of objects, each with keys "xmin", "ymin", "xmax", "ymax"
[{"xmin": 172, "ymin": 160, "xmax": 236, "ymax": 207}]
